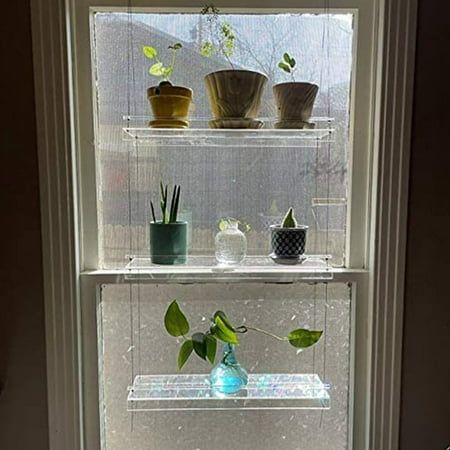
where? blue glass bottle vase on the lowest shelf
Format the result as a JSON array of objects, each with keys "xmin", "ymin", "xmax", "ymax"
[{"xmin": 209, "ymin": 344, "xmax": 248, "ymax": 395}]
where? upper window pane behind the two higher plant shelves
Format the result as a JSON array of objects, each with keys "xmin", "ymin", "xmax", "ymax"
[{"xmin": 92, "ymin": 13, "xmax": 353, "ymax": 267}]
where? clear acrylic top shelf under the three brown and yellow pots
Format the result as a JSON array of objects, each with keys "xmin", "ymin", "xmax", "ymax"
[{"xmin": 123, "ymin": 127, "xmax": 334, "ymax": 148}]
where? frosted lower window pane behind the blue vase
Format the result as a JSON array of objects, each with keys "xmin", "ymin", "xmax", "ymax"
[{"xmin": 99, "ymin": 283, "xmax": 351, "ymax": 450}]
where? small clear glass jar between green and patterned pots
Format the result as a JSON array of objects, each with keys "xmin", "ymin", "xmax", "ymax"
[{"xmin": 215, "ymin": 219, "xmax": 247, "ymax": 264}]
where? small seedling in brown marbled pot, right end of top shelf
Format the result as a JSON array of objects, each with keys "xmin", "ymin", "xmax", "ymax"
[{"xmin": 273, "ymin": 53, "xmax": 319, "ymax": 129}]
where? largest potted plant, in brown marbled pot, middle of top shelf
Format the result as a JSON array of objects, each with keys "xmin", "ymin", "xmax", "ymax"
[{"xmin": 200, "ymin": 5, "xmax": 267, "ymax": 128}]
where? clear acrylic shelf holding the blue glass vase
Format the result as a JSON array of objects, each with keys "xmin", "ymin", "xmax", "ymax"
[{"xmin": 127, "ymin": 374, "xmax": 330, "ymax": 411}]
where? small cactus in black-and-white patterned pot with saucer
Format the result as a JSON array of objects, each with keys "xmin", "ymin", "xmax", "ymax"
[{"xmin": 270, "ymin": 208, "xmax": 308, "ymax": 264}]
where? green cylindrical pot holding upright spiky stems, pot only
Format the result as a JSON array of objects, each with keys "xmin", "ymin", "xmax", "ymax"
[{"xmin": 150, "ymin": 221, "xmax": 188, "ymax": 264}]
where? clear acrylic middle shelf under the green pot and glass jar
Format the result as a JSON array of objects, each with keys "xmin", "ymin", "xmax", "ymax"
[{"xmin": 124, "ymin": 255, "xmax": 333, "ymax": 283}]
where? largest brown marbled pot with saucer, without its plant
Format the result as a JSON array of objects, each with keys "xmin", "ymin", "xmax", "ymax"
[{"xmin": 205, "ymin": 70, "xmax": 267, "ymax": 128}]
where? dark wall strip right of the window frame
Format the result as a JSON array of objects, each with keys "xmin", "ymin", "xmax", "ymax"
[{"xmin": 400, "ymin": 0, "xmax": 450, "ymax": 450}]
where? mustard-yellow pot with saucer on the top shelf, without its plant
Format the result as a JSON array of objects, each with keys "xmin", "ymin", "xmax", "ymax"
[{"xmin": 147, "ymin": 82, "xmax": 192, "ymax": 128}]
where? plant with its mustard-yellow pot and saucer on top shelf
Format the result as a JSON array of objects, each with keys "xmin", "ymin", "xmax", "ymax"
[{"xmin": 143, "ymin": 42, "xmax": 192, "ymax": 128}]
